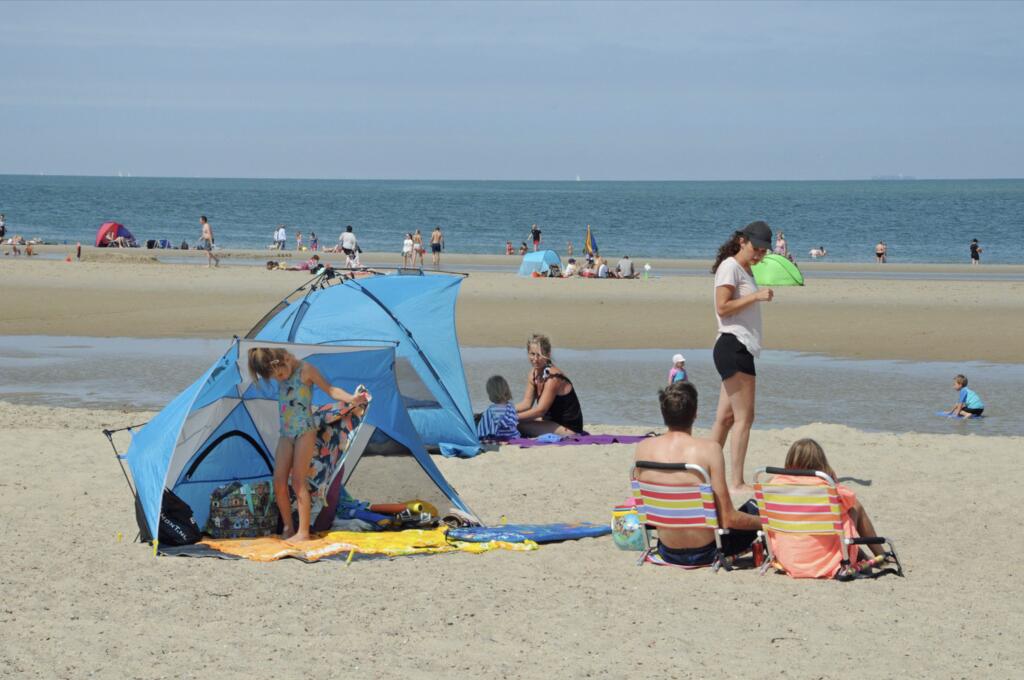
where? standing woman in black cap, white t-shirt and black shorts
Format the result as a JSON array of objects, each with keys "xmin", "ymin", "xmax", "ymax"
[{"xmin": 711, "ymin": 220, "xmax": 774, "ymax": 493}]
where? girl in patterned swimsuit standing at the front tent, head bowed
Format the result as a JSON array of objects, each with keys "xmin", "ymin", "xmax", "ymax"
[{"xmin": 249, "ymin": 347, "xmax": 369, "ymax": 541}]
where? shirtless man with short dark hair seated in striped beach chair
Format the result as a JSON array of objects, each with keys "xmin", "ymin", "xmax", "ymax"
[{"xmin": 633, "ymin": 381, "xmax": 761, "ymax": 566}]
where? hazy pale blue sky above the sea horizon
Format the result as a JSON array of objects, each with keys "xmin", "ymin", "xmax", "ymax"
[{"xmin": 0, "ymin": 1, "xmax": 1024, "ymax": 180}]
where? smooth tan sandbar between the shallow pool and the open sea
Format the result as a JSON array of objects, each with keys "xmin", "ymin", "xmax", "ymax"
[{"xmin": 0, "ymin": 253, "xmax": 1024, "ymax": 363}]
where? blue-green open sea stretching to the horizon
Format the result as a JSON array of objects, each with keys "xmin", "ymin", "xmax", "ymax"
[{"xmin": 0, "ymin": 175, "xmax": 1024, "ymax": 263}]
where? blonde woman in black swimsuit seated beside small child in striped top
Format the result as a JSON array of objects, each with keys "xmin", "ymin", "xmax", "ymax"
[{"xmin": 515, "ymin": 335, "xmax": 583, "ymax": 437}]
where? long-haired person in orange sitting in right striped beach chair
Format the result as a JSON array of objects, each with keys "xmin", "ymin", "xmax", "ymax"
[{"xmin": 771, "ymin": 439, "xmax": 882, "ymax": 579}]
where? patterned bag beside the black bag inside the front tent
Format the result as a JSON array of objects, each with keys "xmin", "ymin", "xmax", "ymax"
[{"xmin": 206, "ymin": 481, "xmax": 280, "ymax": 539}]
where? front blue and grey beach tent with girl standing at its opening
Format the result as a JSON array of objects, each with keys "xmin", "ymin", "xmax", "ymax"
[{"xmin": 125, "ymin": 340, "xmax": 472, "ymax": 536}]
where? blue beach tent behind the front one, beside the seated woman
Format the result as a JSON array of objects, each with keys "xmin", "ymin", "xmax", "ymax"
[{"xmin": 246, "ymin": 274, "xmax": 480, "ymax": 457}]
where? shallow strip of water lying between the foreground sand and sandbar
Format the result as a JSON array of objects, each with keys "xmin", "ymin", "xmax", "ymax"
[{"xmin": 0, "ymin": 336, "xmax": 1024, "ymax": 436}]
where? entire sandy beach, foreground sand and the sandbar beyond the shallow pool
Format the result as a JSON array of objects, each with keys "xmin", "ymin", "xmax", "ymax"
[{"xmin": 0, "ymin": 249, "xmax": 1024, "ymax": 678}]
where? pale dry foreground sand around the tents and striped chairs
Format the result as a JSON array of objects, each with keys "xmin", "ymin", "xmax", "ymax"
[{"xmin": 0, "ymin": 405, "xmax": 1024, "ymax": 680}]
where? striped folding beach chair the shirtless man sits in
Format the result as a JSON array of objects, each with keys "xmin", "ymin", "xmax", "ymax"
[{"xmin": 630, "ymin": 461, "xmax": 745, "ymax": 572}]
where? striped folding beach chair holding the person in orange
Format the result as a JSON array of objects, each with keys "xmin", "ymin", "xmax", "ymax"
[{"xmin": 754, "ymin": 467, "xmax": 903, "ymax": 581}]
